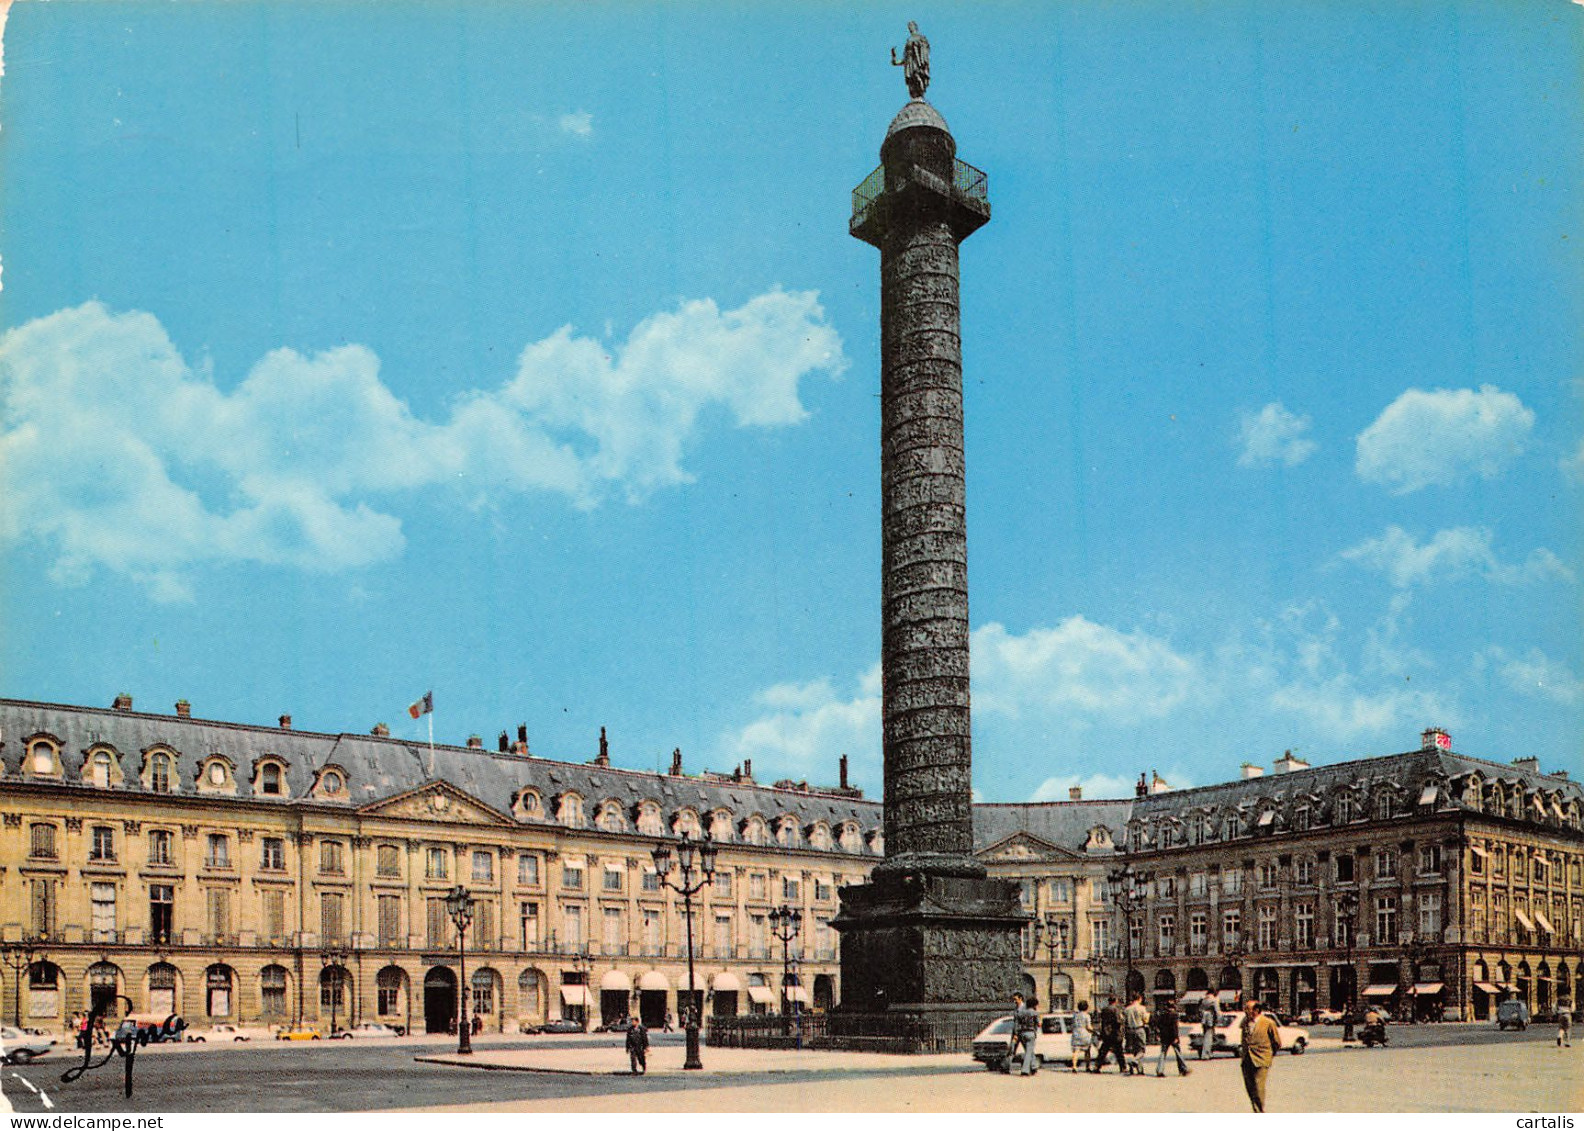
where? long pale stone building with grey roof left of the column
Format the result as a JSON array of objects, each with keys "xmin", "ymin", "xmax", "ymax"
[{"xmin": 0, "ymin": 695, "xmax": 884, "ymax": 1031}]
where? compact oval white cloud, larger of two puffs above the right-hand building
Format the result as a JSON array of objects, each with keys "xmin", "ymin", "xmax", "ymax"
[{"xmin": 1354, "ymin": 385, "xmax": 1535, "ymax": 494}]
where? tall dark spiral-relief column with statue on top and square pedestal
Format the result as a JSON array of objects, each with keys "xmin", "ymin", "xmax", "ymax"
[{"xmin": 833, "ymin": 24, "xmax": 1026, "ymax": 1047}]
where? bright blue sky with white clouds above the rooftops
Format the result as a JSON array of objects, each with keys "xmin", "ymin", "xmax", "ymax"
[{"xmin": 0, "ymin": 0, "xmax": 1584, "ymax": 800}]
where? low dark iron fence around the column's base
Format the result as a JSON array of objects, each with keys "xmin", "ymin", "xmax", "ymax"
[{"xmin": 706, "ymin": 1014, "xmax": 985, "ymax": 1055}]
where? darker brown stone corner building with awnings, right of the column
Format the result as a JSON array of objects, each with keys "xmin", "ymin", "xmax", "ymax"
[{"xmin": 1115, "ymin": 730, "xmax": 1584, "ymax": 1020}]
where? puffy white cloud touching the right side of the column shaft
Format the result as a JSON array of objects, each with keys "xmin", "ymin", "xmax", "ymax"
[{"xmin": 973, "ymin": 616, "xmax": 1198, "ymax": 718}]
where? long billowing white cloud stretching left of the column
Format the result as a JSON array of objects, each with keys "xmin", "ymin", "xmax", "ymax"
[{"xmin": 0, "ymin": 297, "xmax": 846, "ymax": 600}]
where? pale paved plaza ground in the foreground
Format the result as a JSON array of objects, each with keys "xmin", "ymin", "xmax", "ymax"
[{"xmin": 9, "ymin": 1025, "xmax": 1584, "ymax": 1114}]
